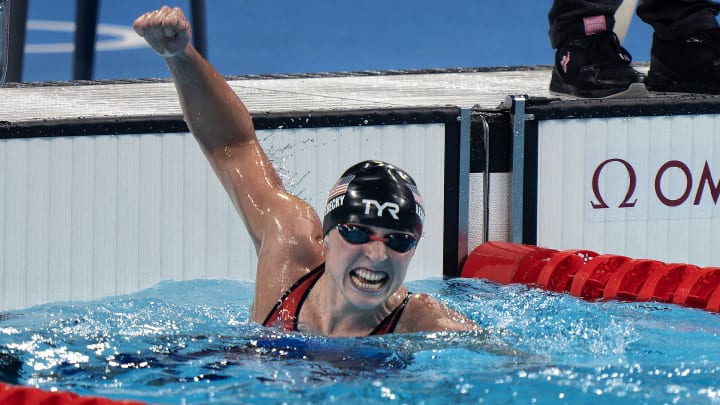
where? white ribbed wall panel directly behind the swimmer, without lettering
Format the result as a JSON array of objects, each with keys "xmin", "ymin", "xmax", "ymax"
[{"xmin": 0, "ymin": 124, "xmax": 446, "ymax": 310}]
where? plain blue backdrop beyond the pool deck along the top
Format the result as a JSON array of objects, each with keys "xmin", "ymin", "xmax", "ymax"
[{"xmin": 18, "ymin": 0, "xmax": 652, "ymax": 81}]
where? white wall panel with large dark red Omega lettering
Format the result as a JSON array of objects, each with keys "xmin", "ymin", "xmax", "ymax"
[{"xmin": 537, "ymin": 115, "xmax": 720, "ymax": 266}]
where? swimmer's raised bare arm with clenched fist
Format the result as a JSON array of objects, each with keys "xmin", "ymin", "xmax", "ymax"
[{"xmin": 134, "ymin": 7, "xmax": 321, "ymax": 252}]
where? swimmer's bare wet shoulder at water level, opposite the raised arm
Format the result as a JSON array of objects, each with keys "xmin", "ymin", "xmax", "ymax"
[{"xmin": 395, "ymin": 293, "xmax": 481, "ymax": 333}]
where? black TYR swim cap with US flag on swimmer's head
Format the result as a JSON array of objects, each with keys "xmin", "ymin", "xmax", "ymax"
[{"xmin": 323, "ymin": 160, "xmax": 425, "ymax": 237}]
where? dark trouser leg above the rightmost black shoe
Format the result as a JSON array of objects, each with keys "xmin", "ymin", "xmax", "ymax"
[{"xmin": 637, "ymin": 0, "xmax": 720, "ymax": 41}]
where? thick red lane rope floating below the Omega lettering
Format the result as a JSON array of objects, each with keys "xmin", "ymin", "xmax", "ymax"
[{"xmin": 460, "ymin": 242, "xmax": 720, "ymax": 312}]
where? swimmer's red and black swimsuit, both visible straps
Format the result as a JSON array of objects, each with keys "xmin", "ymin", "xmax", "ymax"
[{"xmin": 263, "ymin": 263, "xmax": 412, "ymax": 335}]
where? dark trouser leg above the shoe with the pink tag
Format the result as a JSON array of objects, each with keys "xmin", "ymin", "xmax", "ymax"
[{"xmin": 548, "ymin": 0, "xmax": 620, "ymax": 48}]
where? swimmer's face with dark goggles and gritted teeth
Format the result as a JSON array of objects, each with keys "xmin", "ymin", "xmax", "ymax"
[{"xmin": 325, "ymin": 224, "xmax": 415, "ymax": 309}]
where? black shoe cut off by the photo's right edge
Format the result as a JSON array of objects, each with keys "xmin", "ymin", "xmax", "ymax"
[{"xmin": 648, "ymin": 28, "xmax": 720, "ymax": 94}]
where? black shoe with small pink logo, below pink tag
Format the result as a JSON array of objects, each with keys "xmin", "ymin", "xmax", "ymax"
[{"xmin": 550, "ymin": 31, "xmax": 645, "ymax": 97}]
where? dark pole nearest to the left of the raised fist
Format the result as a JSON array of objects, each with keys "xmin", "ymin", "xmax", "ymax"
[{"xmin": 73, "ymin": 0, "xmax": 99, "ymax": 80}]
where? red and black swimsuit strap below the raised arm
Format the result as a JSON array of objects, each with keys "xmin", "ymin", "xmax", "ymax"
[{"xmin": 263, "ymin": 263, "xmax": 325, "ymax": 331}]
